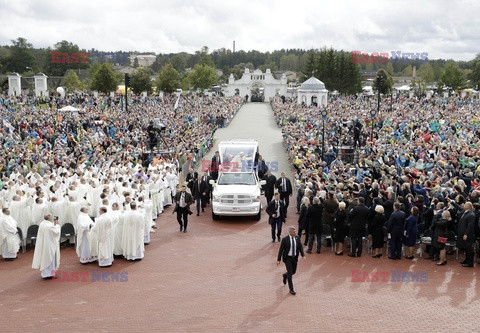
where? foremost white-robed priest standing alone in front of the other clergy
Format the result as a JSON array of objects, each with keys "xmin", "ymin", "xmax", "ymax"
[{"xmin": 32, "ymin": 213, "xmax": 60, "ymax": 279}]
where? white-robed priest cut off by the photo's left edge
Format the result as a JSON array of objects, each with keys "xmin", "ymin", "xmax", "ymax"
[{"xmin": 0, "ymin": 207, "xmax": 21, "ymax": 260}]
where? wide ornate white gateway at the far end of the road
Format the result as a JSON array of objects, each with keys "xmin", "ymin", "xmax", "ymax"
[{"xmin": 225, "ymin": 68, "xmax": 287, "ymax": 102}]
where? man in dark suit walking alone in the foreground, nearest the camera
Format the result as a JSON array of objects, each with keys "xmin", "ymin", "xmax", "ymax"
[{"xmin": 277, "ymin": 226, "xmax": 306, "ymax": 295}]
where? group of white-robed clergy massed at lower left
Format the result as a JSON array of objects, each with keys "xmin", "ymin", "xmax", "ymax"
[{"xmin": 0, "ymin": 158, "xmax": 178, "ymax": 278}]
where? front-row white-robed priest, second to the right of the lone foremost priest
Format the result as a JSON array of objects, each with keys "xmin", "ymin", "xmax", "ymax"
[{"xmin": 90, "ymin": 206, "xmax": 115, "ymax": 267}]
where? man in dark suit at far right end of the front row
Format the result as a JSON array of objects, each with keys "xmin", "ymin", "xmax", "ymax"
[{"xmin": 451, "ymin": 200, "xmax": 476, "ymax": 267}]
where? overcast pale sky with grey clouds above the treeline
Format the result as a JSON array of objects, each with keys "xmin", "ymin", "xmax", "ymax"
[{"xmin": 0, "ymin": 0, "xmax": 480, "ymax": 60}]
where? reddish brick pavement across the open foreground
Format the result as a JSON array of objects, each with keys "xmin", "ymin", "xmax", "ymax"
[{"xmin": 0, "ymin": 196, "xmax": 480, "ymax": 332}]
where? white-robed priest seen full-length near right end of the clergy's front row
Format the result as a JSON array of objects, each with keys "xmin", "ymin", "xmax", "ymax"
[{"xmin": 122, "ymin": 202, "xmax": 145, "ymax": 260}]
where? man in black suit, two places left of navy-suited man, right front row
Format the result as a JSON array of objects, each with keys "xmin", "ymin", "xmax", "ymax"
[{"xmin": 348, "ymin": 197, "xmax": 369, "ymax": 257}]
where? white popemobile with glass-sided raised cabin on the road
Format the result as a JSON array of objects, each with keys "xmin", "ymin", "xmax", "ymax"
[{"xmin": 210, "ymin": 140, "xmax": 265, "ymax": 221}]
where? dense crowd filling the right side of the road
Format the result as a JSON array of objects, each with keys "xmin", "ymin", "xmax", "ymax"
[{"xmin": 271, "ymin": 96, "xmax": 480, "ymax": 267}]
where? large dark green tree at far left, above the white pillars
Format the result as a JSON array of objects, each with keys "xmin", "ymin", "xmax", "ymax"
[{"xmin": 6, "ymin": 37, "xmax": 38, "ymax": 73}]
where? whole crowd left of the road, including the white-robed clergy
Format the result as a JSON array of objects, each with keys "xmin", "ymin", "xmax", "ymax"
[{"xmin": 0, "ymin": 95, "xmax": 242, "ymax": 277}]
